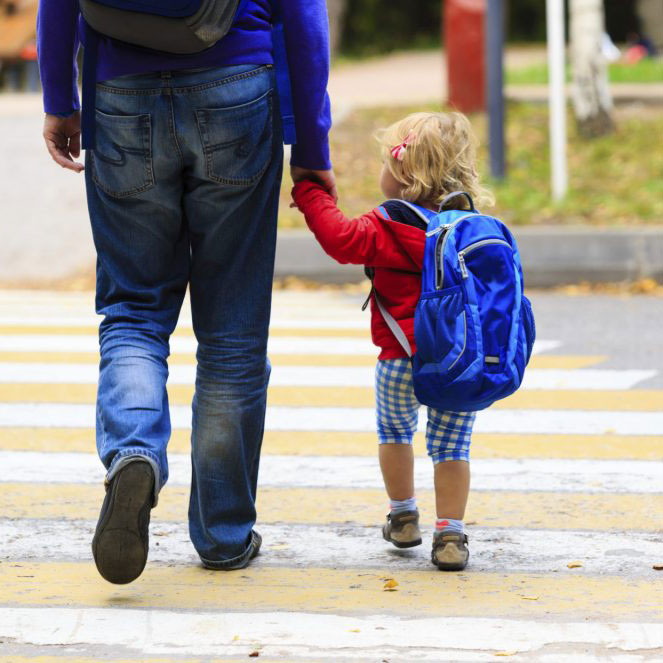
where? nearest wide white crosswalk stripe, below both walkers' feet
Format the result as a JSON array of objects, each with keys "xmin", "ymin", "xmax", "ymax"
[{"xmin": 0, "ymin": 607, "xmax": 663, "ymax": 661}]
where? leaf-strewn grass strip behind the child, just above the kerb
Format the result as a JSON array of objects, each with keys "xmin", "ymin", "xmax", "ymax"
[{"xmin": 280, "ymin": 103, "xmax": 663, "ymax": 228}]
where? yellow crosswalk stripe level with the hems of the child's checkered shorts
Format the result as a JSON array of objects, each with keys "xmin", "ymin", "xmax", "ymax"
[{"xmin": 0, "ymin": 428, "xmax": 663, "ymax": 461}]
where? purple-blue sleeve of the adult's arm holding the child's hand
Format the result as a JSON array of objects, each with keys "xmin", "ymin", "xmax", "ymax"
[{"xmin": 279, "ymin": 0, "xmax": 331, "ymax": 171}]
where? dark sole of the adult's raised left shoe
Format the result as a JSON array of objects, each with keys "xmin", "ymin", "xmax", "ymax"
[{"xmin": 92, "ymin": 461, "xmax": 154, "ymax": 585}]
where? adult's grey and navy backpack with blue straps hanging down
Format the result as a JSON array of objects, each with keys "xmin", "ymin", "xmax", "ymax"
[{"xmin": 79, "ymin": 0, "xmax": 296, "ymax": 149}]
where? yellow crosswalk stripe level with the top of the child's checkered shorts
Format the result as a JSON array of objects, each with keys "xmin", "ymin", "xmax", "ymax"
[{"xmin": 0, "ymin": 348, "xmax": 607, "ymax": 371}]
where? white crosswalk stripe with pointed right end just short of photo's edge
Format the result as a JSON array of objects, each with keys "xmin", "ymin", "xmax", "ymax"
[{"xmin": 0, "ymin": 362, "xmax": 657, "ymax": 390}]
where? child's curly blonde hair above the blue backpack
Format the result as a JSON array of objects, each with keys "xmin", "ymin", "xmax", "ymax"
[{"xmin": 377, "ymin": 113, "xmax": 495, "ymax": 206}]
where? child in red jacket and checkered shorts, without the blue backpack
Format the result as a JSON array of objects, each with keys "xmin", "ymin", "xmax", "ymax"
[{"xmin": 293, "ymin": 113, "xmax": 492, "ymax": 571}]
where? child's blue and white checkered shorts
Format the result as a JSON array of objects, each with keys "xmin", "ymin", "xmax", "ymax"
[{"xmin": 375, "ymin": 359, "xmax": 476, "ymax": 463}]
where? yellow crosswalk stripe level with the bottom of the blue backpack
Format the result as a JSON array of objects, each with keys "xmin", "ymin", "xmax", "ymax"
[{"xmin": 0, "ymin": 383, "xmax": 663, "ymax": 412}]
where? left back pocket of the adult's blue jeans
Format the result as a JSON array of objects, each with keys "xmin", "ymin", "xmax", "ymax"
[{"xmin": 91, "ymin": 111, "xmax": 154, "ymax": 198}]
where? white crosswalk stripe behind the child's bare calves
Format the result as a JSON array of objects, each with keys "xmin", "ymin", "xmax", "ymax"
[{"xmin": 0, "ymin": 451, "xmax": 663, "ymax": 493}]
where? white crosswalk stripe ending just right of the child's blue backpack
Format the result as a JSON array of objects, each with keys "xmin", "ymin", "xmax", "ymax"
[{"xmin": 0, "ymin": 332, "xmax": 560, "ymax": 357}]
